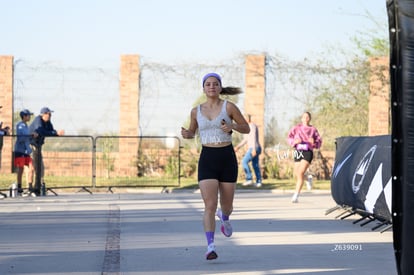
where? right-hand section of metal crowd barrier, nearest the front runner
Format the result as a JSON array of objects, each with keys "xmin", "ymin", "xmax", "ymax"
[{"xmin": 95, "ymin": 136, "xmax": 180, "ymax": 187}]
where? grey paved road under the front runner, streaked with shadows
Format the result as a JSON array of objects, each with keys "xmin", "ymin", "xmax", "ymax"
[{"xmin": 0, "ymin": 190, "xmax": 396, "ymax": 275}]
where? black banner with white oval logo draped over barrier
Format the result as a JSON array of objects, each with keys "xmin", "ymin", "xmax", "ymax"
[{"xmin": 331, "ymin": 135, "xmax": 392, "ymax": 222}]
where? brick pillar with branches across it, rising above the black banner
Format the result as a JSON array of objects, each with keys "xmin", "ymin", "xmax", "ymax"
[{"xmin": 368, "ymin": 57, "xmax": 391, "ymax": 136}]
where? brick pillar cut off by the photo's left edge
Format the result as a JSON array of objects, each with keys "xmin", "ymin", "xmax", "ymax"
[{"xmin": 0, "ymin": 56, "xmax": 14, "ymax": 173}]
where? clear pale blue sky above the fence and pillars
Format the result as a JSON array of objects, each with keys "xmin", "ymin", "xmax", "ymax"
[{"xmin": 0, "ymin": 0, "xmax": 386, "ymax": 65}]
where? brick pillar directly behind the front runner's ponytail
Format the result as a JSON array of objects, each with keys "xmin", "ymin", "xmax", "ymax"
[{"xmin": 244, "ymin": 55, "xmax": 266, "ymax": 151}]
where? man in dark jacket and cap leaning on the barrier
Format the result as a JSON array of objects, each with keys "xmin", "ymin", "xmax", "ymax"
[{"xmin": 29, "ymin": 107, "xmax": 65, "ymax": 193}]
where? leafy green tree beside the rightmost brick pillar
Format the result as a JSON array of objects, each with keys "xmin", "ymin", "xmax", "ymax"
[{"xmin": 290, "ymin": 22, "xmax": 389, "ymax": 150}]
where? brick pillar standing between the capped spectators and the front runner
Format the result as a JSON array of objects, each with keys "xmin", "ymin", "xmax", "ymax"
[{"xmin": 119, "ymin": 55, "xmax": 140, "ymax": 176}]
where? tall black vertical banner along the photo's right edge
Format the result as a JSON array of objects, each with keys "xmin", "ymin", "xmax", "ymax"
[{"xmin": 386, "ymin": 0, "xmax": 414, "ymax": 275}]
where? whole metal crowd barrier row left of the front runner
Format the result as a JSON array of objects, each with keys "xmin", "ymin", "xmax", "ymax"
[{"xmin": 0, "ymin": 135, "xmax": 181, "ymax": 194}]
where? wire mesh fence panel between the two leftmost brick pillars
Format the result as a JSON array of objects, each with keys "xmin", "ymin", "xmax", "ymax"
[{"xmin": 13, "ymin": 59, "xmax": 119, "ymax": 135}]
